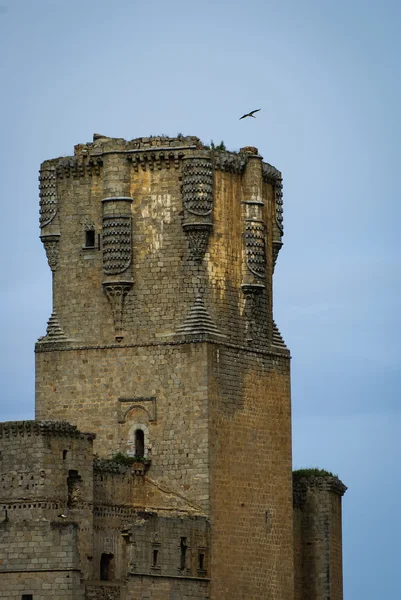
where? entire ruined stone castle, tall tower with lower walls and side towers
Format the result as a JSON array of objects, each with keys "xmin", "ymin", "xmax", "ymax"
[{"xmin": 0, "ymin": 135, "xmax": 345, "ymax": 600}]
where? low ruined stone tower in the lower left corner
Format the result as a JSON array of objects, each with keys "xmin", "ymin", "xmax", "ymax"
[{"xmin": 0, "ymin": 421, "xmax": 94, "ymax": 600}]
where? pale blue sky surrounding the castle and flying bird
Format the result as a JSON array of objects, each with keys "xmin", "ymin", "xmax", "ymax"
[{"xmin": 0, "ymin": 0, "xmax": 401, "ymax": 600}]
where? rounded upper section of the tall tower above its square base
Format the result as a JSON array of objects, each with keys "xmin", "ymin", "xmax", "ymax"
[{"xmin": 36, "ymin": 134, "xmax": 287, "ymax": 353}]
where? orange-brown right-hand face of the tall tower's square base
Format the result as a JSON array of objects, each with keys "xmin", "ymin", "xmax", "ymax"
[{"xmin": 209, "ymin": 346, "xmax": 294, "ymax": 600}]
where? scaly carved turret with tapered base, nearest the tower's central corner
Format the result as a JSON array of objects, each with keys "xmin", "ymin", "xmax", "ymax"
[{"xmin": 182, "ymin": 156, "xmax": 213, "ymax": 262}]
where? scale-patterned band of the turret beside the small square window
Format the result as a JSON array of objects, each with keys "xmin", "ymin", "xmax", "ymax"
[{"xmin": 103, "ymin": 215, "xmax": 132, "ymax": 275}]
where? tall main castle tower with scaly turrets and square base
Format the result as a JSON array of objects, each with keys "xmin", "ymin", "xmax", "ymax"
[{"xmin": 36, "ymin": 136, "xmax": 294, "ymax": 600}]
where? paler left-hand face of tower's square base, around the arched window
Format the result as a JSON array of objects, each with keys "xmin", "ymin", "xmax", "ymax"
[{"xmin": 36, "ymin": 344, "xmax": 208, "ymax": 510}]
